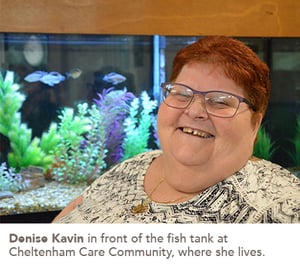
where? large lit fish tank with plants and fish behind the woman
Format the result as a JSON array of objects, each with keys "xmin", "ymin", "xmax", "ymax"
[{"xmin": 0, "ymin": 33, "xmax": 300, "ymax": 222}]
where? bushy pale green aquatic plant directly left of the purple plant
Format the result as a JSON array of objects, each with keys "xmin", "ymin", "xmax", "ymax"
[{"xmin": 51, "ymin": 103, "xmax": 106, "ymax": 184}]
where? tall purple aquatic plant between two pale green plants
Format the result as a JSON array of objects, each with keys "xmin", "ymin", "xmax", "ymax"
[{"xmin": 94, "ymin": 87, "xmax": 135, "ymax": 166}]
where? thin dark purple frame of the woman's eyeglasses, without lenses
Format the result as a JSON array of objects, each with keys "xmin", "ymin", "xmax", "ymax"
[{"xmin": 161, "ymin": 82, "xmax": 255, "ymax": 118}]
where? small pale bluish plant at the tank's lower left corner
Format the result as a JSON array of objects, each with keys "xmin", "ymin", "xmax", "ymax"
[{"xmin": 0, "ymin": 162, "xmax": 29, "ymax": 192}]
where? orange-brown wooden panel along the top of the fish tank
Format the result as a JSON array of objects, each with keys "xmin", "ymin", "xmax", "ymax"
[{"xmin": 0, "ymin": 0, "xmax": 300, "ymax": 37}]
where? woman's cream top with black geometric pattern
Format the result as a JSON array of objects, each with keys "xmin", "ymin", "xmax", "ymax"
[{"xmin": 56, "ymin": 150, "xmax": 300, "ymax": 223}]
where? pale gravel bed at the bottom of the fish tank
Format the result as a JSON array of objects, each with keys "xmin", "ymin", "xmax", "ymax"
[{"xmin": 0, "ymin": 182, "xmax": 86, "ymax": 216}]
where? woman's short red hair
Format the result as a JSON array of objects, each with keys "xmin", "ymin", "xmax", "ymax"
[{"xmin": 171, "ymin": 36, "xmax": 270, "ymax": 115}]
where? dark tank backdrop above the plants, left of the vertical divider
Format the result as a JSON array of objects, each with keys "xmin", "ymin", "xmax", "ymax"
[{"xmin": 0, "ymin": 34, "xmax": 153, "ymax": 141}]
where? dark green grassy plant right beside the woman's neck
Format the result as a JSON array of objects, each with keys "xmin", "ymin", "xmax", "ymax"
[{"xmin": 253, "ymin": 125, "xmax": 276, "ymax": 160}]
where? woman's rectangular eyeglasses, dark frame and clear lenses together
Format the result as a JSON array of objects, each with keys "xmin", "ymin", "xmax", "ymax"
[{"xmin": 161, "ymin": 82, "xmax": 253, "ymax": 117}]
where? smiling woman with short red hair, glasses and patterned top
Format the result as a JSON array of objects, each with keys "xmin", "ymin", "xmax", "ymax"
[{"xmin": 54, "ymin": 36, "xmax": 300, "ymax": 223}]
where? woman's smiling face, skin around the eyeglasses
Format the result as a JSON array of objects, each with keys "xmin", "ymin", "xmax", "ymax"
[{"xmin": 158, "ymin": 63, "xmax": 261, "ymax": 175}]
